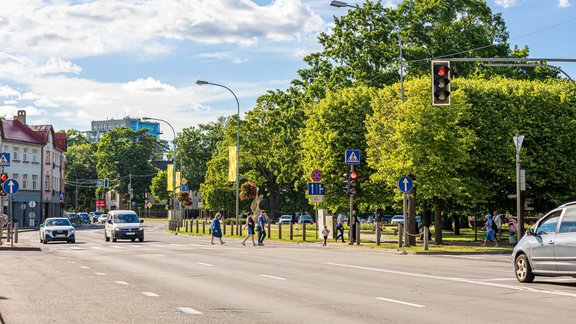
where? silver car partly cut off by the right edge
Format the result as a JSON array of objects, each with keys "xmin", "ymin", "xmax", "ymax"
[{"xmin": 512, "ymin": 202, "xmax": 576, "ymax": 282}]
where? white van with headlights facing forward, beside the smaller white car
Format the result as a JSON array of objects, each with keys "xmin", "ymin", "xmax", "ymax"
[{"xmin": 104, "ymin": 210, "xmax": 144, "ymax": 242}]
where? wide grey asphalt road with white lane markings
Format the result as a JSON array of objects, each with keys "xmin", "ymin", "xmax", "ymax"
[{"xmin": 0, "ymin": 222, "xmax": 576, "ymax": 323}]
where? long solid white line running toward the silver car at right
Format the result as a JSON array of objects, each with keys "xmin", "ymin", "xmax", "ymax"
[{"xmin": 322, "ymin": 262, "xmax": 576, "ymax": 298}]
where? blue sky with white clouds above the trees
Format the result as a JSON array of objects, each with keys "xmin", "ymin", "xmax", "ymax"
[{"xmin": 0, "ymin": 0, "xmax": 576, "ymax": 140}]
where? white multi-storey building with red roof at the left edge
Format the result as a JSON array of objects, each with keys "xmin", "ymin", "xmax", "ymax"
[{"xmin": 0, "ymin": 110, "xmax": 66, "ymax": 226}]
